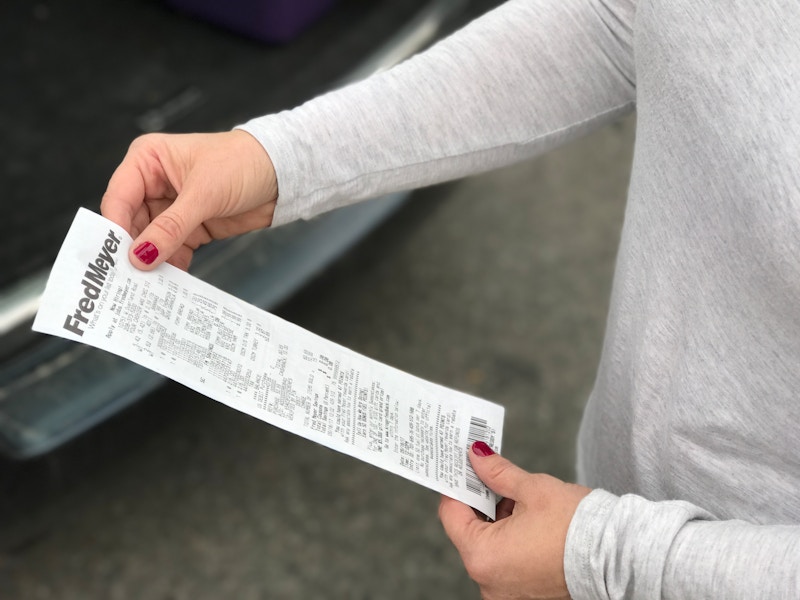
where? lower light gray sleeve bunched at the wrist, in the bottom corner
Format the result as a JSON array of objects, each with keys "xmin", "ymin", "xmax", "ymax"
[{"xmin": 564, "ymin": 490, "xmax": 800, "ymax": 600}]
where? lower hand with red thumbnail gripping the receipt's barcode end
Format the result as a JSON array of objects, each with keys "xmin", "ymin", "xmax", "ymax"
[{"xmin": 439, "ymin": 442, "xmax": 591, "ymax": 600}]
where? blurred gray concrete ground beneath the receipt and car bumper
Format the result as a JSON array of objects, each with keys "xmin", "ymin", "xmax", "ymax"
[{"xmin": 0, "ymin": 119, "xmax": 634, "ymax": 600}]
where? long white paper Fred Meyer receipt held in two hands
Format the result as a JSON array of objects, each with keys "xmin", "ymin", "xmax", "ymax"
[{"xmin": 33, "ymin": 209, "xmax": 504, "ymax": 518}]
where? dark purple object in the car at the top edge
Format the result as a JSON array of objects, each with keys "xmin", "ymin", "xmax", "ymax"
[{"xmin": 167, "ymin": 0, "xmax": 336, "ymax": 42}]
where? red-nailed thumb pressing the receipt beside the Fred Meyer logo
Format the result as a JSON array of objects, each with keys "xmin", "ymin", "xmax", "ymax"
[{"xmin": 129, "ymin": 196, "xmax": 204, "ymax": 271}]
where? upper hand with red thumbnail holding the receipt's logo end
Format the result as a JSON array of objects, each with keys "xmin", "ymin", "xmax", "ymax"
[{"xmin": 100, "ymin": 130, "xmax": 278, "ymax": 270}]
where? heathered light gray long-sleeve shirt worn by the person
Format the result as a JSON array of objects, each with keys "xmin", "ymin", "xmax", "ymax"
[{"xmin": 238, "ymin": 0, "xmax": 800, "ymax": 599}]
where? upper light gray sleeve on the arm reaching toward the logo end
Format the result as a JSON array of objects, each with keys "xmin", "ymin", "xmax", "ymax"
[{"xmin": 240, "ymin": 0, "xmax": 635, "ymax": 225}]
